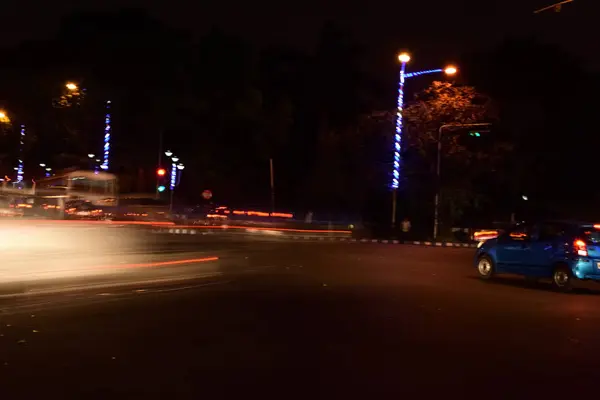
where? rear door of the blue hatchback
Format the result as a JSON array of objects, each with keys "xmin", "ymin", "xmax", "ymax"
[{"xmin": 521, "ymin": 222, "xmax": 569, "ymax": 277}]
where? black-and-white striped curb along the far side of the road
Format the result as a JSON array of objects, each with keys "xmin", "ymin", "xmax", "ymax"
[{"xmin": 152, "ymin": 228, "xmax": 477, "ymax": 248}]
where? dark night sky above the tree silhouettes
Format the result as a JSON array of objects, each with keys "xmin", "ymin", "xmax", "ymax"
[{"xmin": 1, "ymin": 0, "xmax": 600, "ymax": 69}]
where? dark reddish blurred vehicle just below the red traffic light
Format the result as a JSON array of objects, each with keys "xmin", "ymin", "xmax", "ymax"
[{"xmin": 114, "ymin": 194, "xmax": 172, "ymax": 222}]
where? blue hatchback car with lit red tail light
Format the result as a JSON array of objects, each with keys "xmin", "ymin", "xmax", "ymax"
[{"xmin": 475, "ymin": 221, "xmax": 600, "ymax": 291}]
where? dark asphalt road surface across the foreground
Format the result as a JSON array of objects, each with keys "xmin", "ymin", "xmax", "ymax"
[{"xmin": 0, "ymin": 241, "xmax": 600, "ymax": 399}]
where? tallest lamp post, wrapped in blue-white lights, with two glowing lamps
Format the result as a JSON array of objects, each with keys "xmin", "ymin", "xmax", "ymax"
[{"xmin": 391, "ymin": 53, "xmax": 458, "ymax": 228}]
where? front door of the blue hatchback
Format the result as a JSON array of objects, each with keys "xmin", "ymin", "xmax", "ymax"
[{"xmin": 496, "ymin": 225, "xmax": 530, "ymax": 273}]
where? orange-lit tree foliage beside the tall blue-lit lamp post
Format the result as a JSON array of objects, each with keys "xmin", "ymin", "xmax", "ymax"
[{"xmin": 404, "ymin": 82, "xmax": 509, "ymax": 230}]
